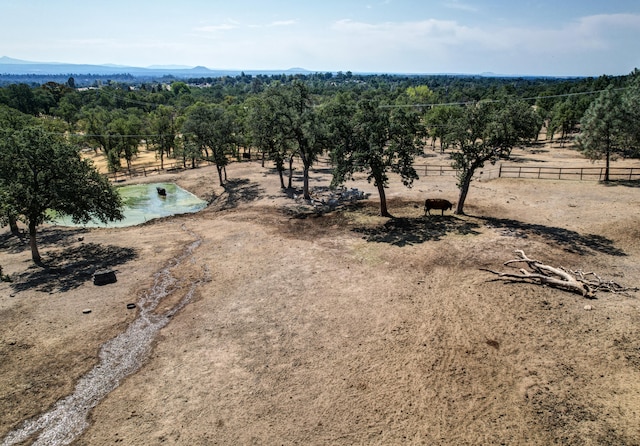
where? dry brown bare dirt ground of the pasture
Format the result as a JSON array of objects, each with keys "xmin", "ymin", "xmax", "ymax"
[{"xmin": 0, "ymin": 147, "xmax": 640, "ymax": 445}]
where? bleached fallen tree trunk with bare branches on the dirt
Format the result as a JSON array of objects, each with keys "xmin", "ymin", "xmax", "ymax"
[{"xmin": 482, "ymin": 249, "xmax": 638, "ymax": 299}]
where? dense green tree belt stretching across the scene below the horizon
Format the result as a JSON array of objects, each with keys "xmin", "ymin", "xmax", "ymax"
[{"xmin": 0, "ymin": 71, "xmax": 640, "ymax": 262}]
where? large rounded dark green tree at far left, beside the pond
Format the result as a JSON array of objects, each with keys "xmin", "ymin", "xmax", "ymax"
[{"xmin": 0, "ymin": 125, "xmax": 123, "ymax": 263}]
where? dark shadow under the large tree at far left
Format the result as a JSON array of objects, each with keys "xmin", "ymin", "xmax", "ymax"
[{"xmin": 11, "ymin": 243, "xmax": 138, "ymax": 292}]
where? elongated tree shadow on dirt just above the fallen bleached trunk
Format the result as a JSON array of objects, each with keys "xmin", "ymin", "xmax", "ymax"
[{"xmin": 477, "ymin": 217, "xmax": 627, "ymax": 256}]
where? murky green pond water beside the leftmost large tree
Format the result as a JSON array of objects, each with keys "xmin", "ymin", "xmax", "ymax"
[{"xmin": 54, "ymin": 183, "xmax": 207, "ymax": 228}]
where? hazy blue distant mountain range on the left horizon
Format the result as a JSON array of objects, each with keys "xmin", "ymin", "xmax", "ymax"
[{"xmin": 0, "ymin": 56, "xmax": 311, "ymax": 78}]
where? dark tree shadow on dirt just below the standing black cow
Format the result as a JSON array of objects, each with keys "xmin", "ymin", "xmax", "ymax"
[{"xmin": 353, "ymin": 216, "xmax": 480, "ymax": 247}]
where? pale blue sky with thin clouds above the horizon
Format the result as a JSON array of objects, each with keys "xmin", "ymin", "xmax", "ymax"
[{"xmin": 0, "ymin": 0, "xmax": 640, "ymax": 76}]
